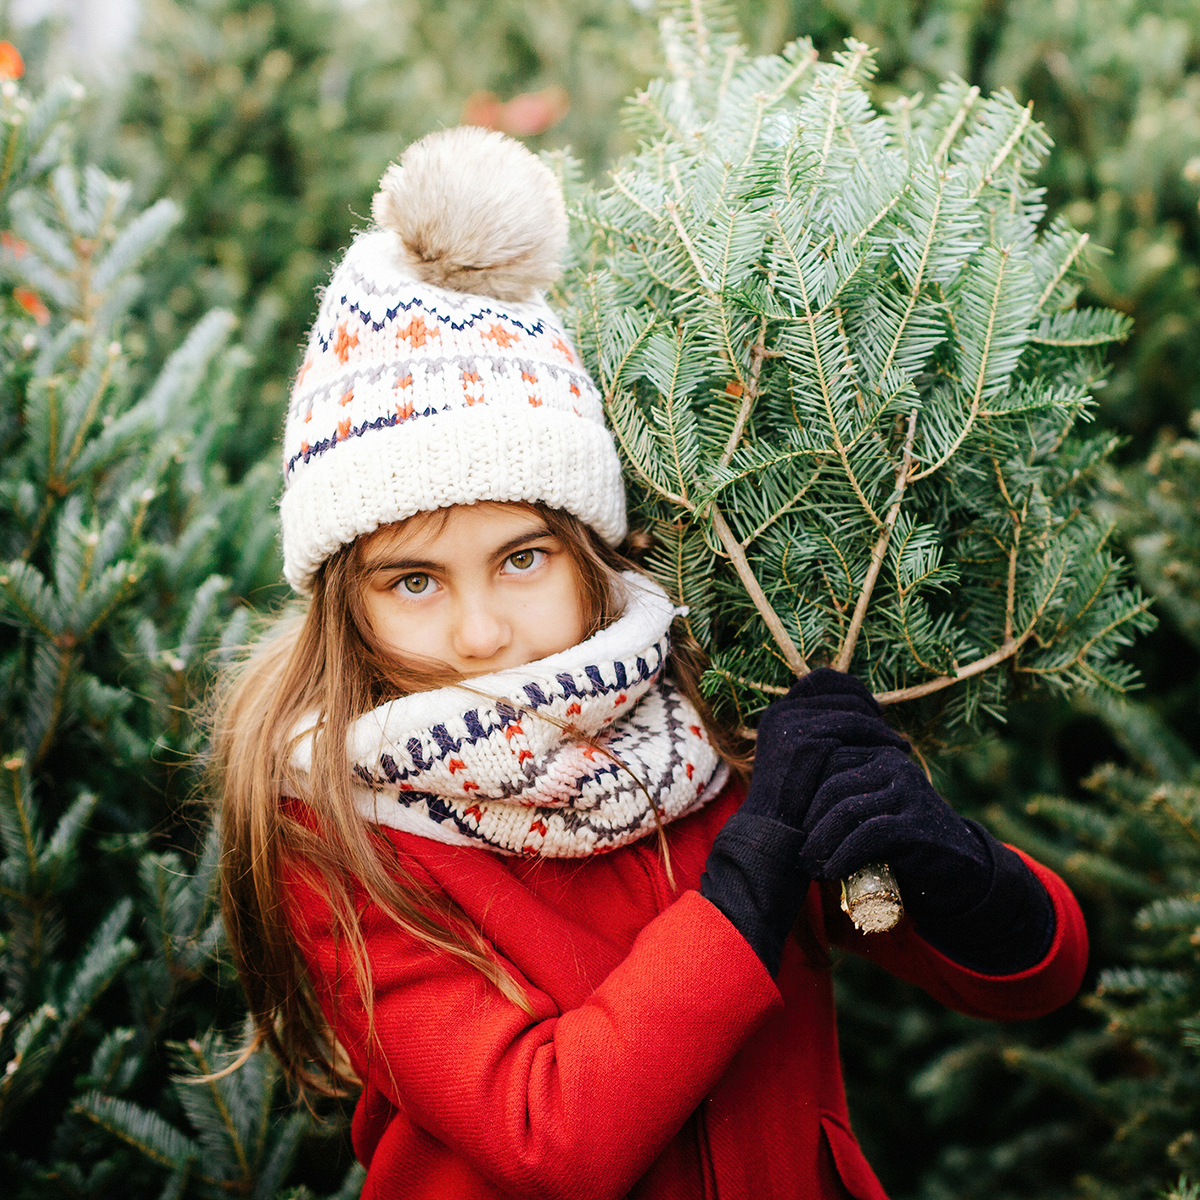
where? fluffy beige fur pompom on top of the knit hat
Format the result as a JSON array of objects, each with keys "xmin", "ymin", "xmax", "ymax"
[{"xmin": 371, "ymin": 125, "xmax": 566, "ymax": 301}]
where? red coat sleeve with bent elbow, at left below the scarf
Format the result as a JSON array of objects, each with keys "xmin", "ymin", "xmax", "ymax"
[{"xmin": 288, "ymin": 874, "xmax": 782, "ymax": 1200}]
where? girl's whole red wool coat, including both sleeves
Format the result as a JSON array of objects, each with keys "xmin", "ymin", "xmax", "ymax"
[{"xmin": 288, "ymin": 786, "xmax": 1087, "ymax": 1200}]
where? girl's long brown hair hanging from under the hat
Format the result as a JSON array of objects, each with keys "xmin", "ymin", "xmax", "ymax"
[{"xmin": 214, "ymin": 505, "xmax": 750, "ymax": 1094}]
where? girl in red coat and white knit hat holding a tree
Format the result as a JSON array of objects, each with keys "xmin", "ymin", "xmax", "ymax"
[{"xmin": 217, "ymin": 128, "xmax": 1086, "ymax": 1200}]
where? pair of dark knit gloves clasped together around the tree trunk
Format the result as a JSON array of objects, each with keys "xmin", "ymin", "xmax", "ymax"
[{"xmin": 701, "ymin": 670, "xmax": 1055, "ymax": 974}]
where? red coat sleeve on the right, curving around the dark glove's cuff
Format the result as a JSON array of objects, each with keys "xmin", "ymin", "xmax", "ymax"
[{"xmin": 829, "ymin": 847, "xmax": 1087, "ymax": 1021}]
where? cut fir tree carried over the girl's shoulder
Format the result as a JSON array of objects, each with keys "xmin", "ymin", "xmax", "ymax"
[{"xmin": 568, "ymin": 0, "xmax": 1152, "ymax": 928}]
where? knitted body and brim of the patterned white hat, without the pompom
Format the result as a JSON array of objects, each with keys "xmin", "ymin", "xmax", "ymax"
[{"xmin": 274, "ymin": 230, "xmax": 625, "ymax": 592}]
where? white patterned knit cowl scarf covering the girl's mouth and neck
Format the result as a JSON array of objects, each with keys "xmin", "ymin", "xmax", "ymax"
[{"xmin": 293, "ymin": 572, "xmax": 728, "ymax": 858}]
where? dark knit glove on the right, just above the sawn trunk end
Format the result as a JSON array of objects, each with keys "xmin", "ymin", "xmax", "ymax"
[{"xmin": 800, "ymin": 746, "xmax": 1055, "ymax": 974}]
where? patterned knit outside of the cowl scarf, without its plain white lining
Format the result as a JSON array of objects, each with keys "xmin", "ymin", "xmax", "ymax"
[{"xmin": 354, "ymin": 643, "xmax": 719, "ymax": 858}]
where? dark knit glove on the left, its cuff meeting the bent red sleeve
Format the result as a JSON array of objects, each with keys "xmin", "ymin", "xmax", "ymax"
[{"xmin": 700, "ymin": 670, "xmax": 907, "ymax": 974}]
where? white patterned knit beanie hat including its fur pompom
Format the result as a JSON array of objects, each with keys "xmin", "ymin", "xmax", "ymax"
[{"xmin": 280, "ymin": 126, "xmax": 625, "ymax": 594}]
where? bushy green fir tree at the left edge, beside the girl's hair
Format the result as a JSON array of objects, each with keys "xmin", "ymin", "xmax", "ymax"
[{"xmin": 0, "ymin": 58, "xmax": 361, "ymax": 1196}]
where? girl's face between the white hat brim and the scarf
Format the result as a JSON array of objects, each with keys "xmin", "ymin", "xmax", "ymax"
[{"xmin": 361, "ymin": 503, "xmax": 584, "ymax": 678}]
